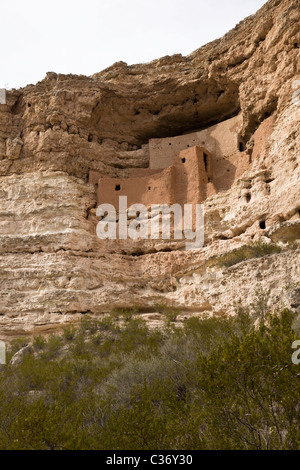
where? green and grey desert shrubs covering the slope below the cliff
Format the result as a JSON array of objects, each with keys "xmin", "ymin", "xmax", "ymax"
[{"xmin": 0, "ymin": 309, "xmax": 300, "ymax": 450}]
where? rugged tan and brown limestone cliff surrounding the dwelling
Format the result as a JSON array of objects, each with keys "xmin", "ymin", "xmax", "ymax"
[{"xmin": 0, "ymin": 0, "xmax": 300, "ymax": 337}]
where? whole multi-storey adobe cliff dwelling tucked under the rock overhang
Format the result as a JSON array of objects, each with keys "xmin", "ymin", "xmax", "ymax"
[{"xmin": 89, "ymin": 114, "xmax": 250, "ymax": 211}]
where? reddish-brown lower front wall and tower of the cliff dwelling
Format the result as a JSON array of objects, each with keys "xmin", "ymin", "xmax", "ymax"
[{"xmin": 94, "ymin": 146, "xmax": 212, "ymax": 208}]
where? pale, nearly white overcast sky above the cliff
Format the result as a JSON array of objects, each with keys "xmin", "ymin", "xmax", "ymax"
[{"xmin": 0, "ymin": 0, "xmax": 266, "ymax": 88}]
